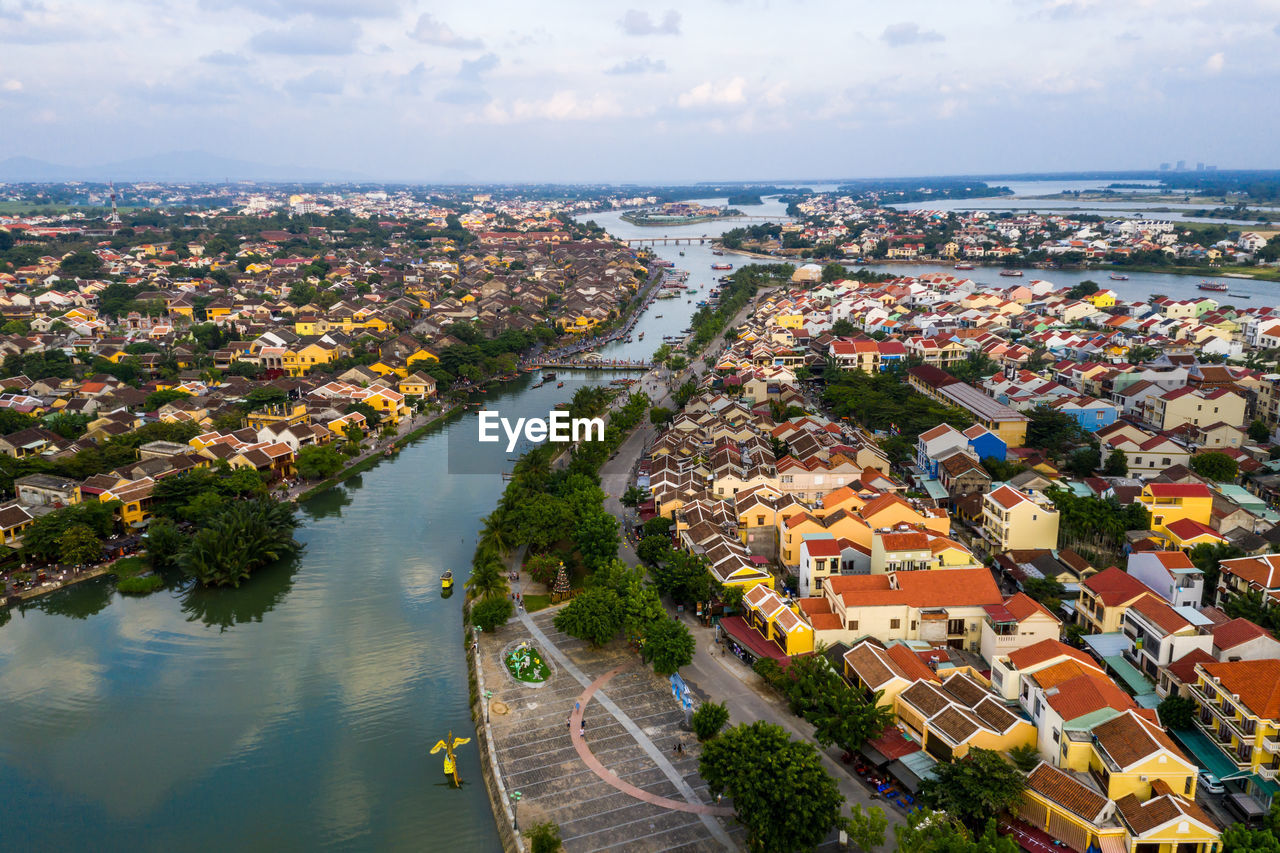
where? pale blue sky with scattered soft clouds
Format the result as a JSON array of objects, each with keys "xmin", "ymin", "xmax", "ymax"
[{"xmin": 0, "ymin": 0, "xmax": 1280, "ymax": 182}]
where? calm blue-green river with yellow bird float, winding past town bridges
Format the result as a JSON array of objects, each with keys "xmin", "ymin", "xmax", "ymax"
[{"xmin": 0, "ymin": 234, "xmax": 732, "ymax": 850}]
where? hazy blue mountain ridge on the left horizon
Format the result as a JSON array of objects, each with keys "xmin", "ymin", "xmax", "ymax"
[{"xmin": 0, "ymin": 151, "xmax": 369, "ymax": 183}]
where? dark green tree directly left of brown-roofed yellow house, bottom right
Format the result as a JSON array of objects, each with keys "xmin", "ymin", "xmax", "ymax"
[{"xmin": 920, "ymin": 747, "xmax": 1027, "ymax": 830}]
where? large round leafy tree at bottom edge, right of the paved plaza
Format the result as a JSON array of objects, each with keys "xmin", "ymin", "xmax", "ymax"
[{"xmin": 698, "ymin": 721, "xmax": 845, "ymax": 853}]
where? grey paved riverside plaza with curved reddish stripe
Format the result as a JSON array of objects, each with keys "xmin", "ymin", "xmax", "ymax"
[{"xmin": 480, "ymin": 608, "xmax": 744, "ymax": 853}]
